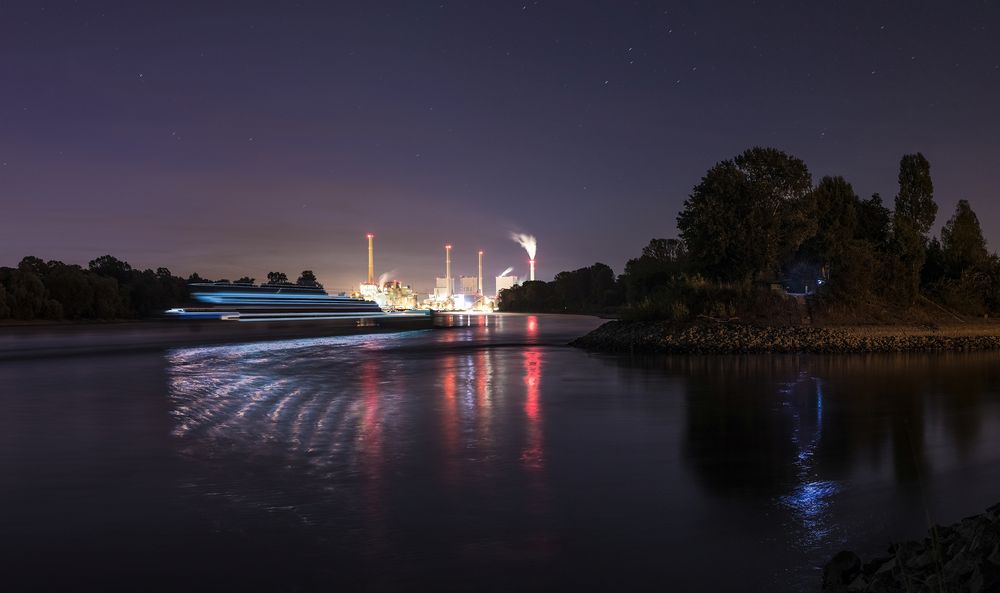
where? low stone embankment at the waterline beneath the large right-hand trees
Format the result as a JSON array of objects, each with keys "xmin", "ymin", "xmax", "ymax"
[{"xmin": 571, "ymin": 321, "xmax": 1000, "ymax": 354}]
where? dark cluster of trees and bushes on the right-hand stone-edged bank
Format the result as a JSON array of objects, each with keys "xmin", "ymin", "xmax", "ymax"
[{"xmin": 500, "ymin": 147, "xmax": 1000, "ymax": 320}]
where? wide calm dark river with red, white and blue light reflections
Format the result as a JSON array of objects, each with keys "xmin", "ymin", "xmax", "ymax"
[{"xmin": 0, "ymin": 315, "xmax": 1000, "ymax": 592}]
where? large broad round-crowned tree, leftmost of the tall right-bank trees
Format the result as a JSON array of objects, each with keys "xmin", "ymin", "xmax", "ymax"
[{"xmin": 677, "ymin": 147, "xmax": 815, "ymax": 280}]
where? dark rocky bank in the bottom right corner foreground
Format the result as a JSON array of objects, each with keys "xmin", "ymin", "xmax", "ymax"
[{"xmin": 822, "ymin": 505, "xmax": 1000, "ymax": 593}]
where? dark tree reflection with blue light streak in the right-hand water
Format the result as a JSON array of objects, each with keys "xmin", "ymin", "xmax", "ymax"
[{"xmin": 615, "ymin": 353, "xmax": 1000, "ymax": 551}]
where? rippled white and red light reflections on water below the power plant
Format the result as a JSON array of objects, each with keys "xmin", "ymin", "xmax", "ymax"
[{"xmin": 168, "ymin": 317, "xmax": 545, "ymax": 550}]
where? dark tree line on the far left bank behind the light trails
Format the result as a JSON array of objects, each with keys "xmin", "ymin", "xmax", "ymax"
[{"xmin": 0, "ymin": 255, "xmax": 323, "ymax": 321}]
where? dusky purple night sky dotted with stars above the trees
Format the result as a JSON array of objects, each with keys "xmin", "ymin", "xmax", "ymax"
[{"xmin": 0, "ymin": 0, "xmax": 1000, "ymax": 289}]
